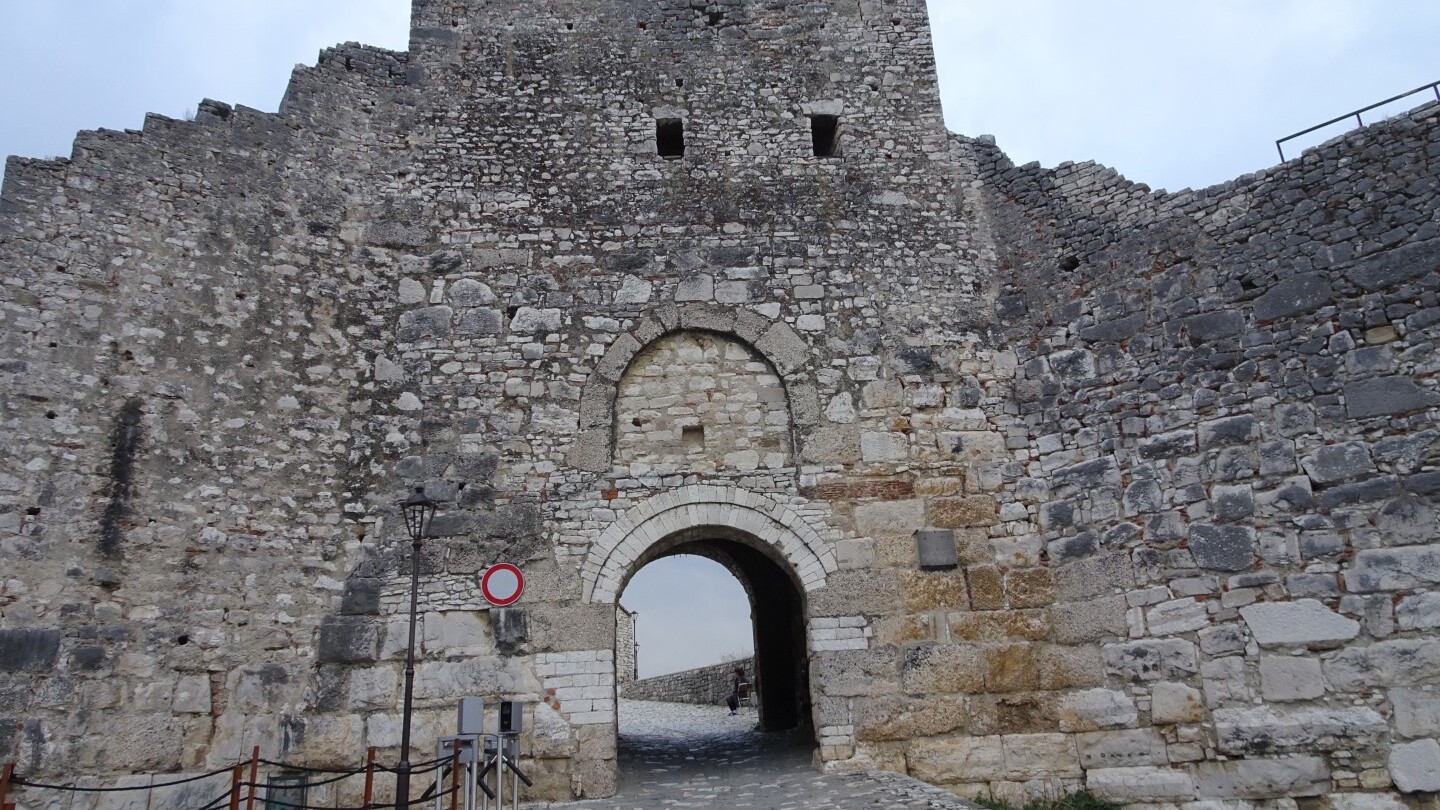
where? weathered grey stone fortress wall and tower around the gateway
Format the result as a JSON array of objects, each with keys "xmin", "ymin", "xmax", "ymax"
[{"xmin": 0, "ymin": 0, "xmax": 1440, "ymax": 809}]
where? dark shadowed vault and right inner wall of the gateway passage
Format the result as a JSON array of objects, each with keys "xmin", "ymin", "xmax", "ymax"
[{"xmin": 619, "ymin": 526, "xmax": 811, "ymax": 731}]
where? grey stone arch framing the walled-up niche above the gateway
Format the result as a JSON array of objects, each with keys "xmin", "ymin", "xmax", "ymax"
[{"xmin": 566, "ymin": 304, "xmax": 821, "ymax": 473}]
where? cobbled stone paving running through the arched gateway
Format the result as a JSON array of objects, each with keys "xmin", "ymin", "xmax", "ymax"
[{"xmin": 531, "ymin": 700, "xmax": 976, "ymax": 810}]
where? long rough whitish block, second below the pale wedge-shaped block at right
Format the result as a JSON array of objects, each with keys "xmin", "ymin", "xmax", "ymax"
[{"xmin": 1214, "ymin": 706, "xmax": 1390, "ymax": 757}]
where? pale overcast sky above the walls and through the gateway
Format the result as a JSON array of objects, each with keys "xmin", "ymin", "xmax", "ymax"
[{"xmin": 0, "ymin": 0, "xmax": 1440, "ymax": 672}]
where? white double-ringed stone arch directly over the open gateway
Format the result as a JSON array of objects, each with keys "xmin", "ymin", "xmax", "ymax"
[{"xmin": 580, "ymin": 484, "xmax": 837, "ymax": 604}]
